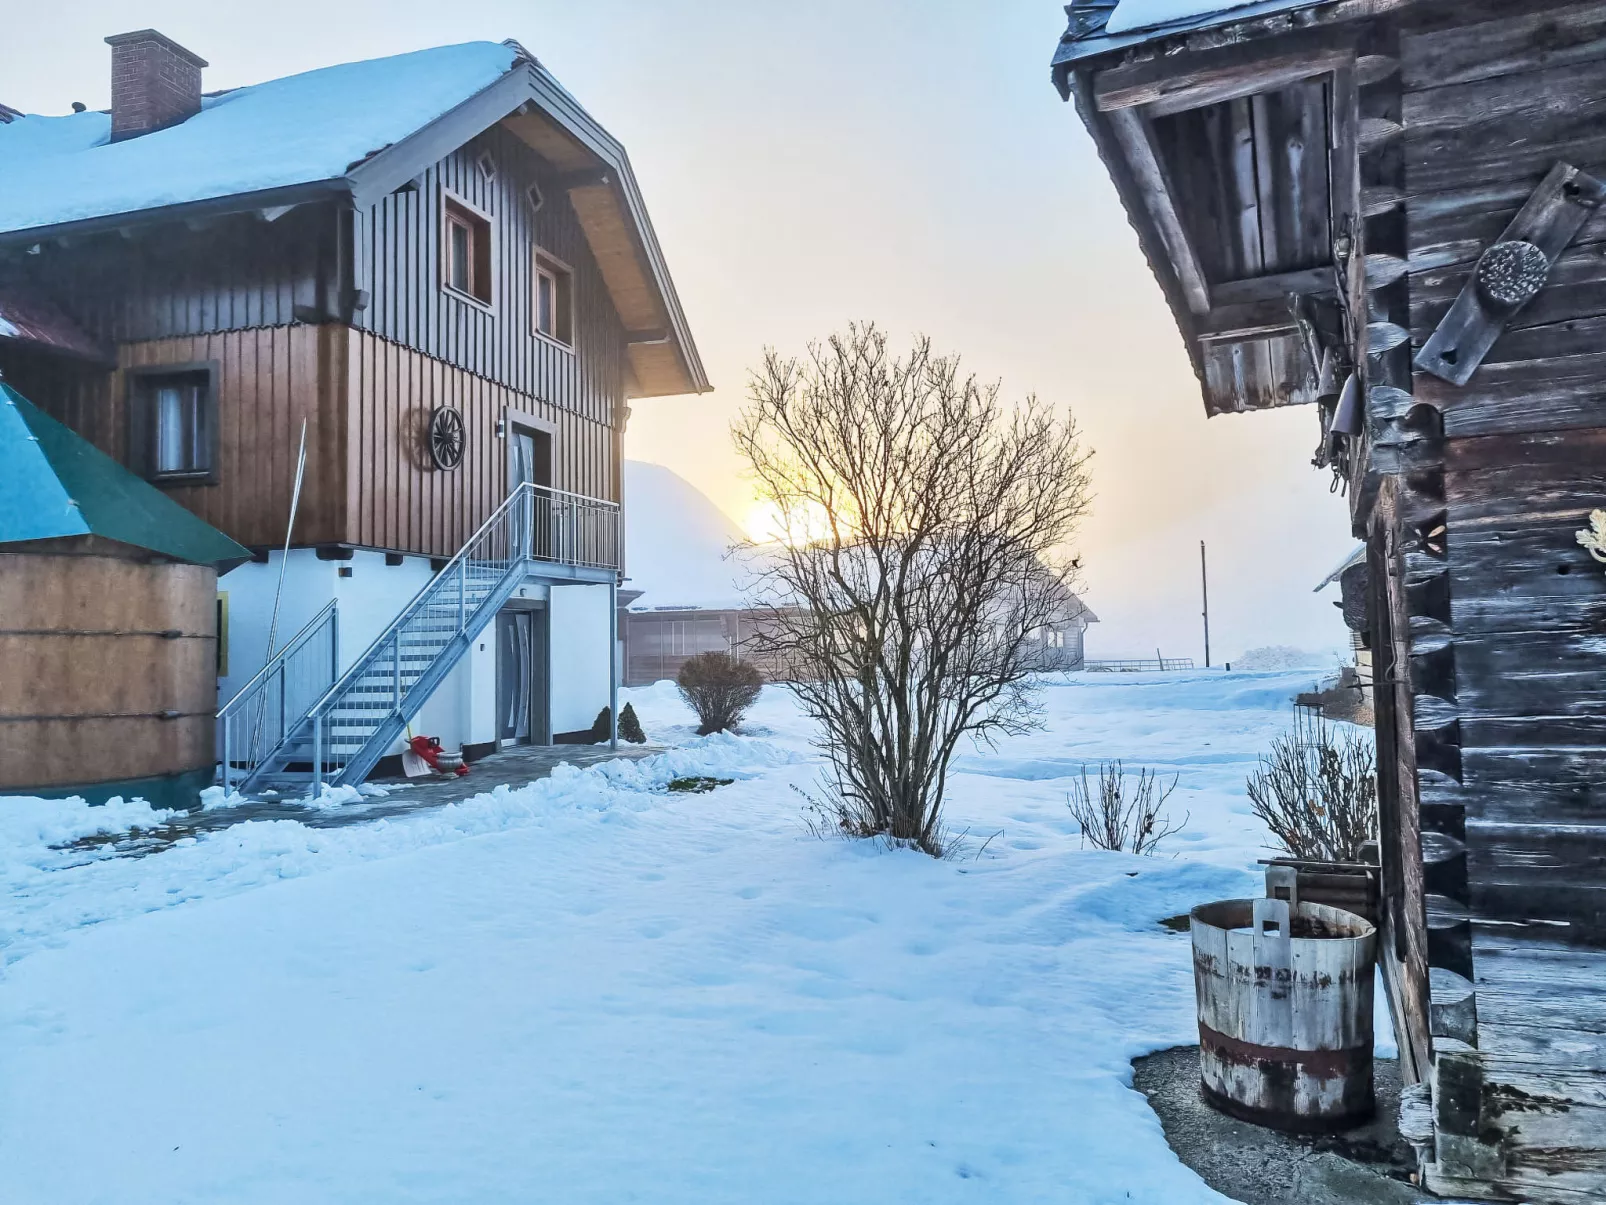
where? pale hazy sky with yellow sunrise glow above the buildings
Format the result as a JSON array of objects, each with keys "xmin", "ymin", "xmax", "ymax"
[{"xmin": 0, "ymin": 0, "xmax": 1354, "ymax": 664}]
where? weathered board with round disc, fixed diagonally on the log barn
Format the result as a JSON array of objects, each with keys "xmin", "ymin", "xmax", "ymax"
[{"xmin": 1415, "ymin": 162, "xmax": 1606, "ymax": 386}]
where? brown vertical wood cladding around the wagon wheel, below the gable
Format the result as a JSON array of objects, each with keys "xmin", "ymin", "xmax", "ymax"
[{"xmin": 344, "ymin": 331, "xmax": 618, "ymax": 556}]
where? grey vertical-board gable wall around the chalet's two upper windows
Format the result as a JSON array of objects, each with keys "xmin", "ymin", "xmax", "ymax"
[{"xmin": 357, "ymin": 125, "xmax": 626, "ymax": 440}]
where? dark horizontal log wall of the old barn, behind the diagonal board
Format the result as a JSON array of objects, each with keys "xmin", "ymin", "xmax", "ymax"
[{"xmin": 1400, "ymin": 0, "xmax": 1606, "ymax": 1202}]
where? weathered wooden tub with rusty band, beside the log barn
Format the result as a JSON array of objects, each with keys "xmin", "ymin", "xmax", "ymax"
[{"xmin": 1192, "ymin": 900, "xmax": 1376, "ymax": 1133}]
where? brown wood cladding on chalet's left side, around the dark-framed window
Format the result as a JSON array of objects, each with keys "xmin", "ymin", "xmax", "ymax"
[{"xmin": 5, "ymin": 325, "xmax": 345, "ymax": 548}]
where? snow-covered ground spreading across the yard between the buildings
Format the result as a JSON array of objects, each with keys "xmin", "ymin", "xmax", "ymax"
[{"xmin": 0, "ymin": 672, "xmax": 1381, "ymax": 1205}]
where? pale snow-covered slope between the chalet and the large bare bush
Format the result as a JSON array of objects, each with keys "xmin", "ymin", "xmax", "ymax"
[{"xmin": 625, "ymin": 460, "xmax": 742, "ymax": 611}]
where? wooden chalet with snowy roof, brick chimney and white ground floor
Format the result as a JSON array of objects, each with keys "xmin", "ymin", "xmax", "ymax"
[{"xmin": 0, "ymin": 31, "xmax": 708, "ymax": 786}]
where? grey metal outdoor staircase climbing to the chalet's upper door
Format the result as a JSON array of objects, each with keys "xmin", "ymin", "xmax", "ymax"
[{"xmin": 218, "ymin": 484, "xmax": 620, "ymax": 794}]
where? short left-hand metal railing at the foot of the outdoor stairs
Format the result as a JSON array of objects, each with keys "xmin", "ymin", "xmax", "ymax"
[{"xmin": 217, "ymin": 599, "xmax": 340, "ymax": 789}]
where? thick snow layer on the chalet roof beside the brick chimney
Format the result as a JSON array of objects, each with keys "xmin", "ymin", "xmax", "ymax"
[{"xmin": 0, "ymin": 42, "xmax": 519, "ymax": 233}]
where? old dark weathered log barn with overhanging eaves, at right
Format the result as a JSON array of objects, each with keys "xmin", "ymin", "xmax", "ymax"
[{"xmin": 1052, "ymin": 0, "xmax": 1606, "ymax": 1202}]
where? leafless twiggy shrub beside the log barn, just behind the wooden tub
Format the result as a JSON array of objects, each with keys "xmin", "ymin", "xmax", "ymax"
[{"xmin": 1249, "ymin": 712, "xmax": 1378, "ymax": 861}]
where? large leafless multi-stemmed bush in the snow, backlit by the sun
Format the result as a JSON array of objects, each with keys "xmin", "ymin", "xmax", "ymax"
[{"xmin": 734, "ymin": 325, "xmax": 1089, "ymax": 855}]
